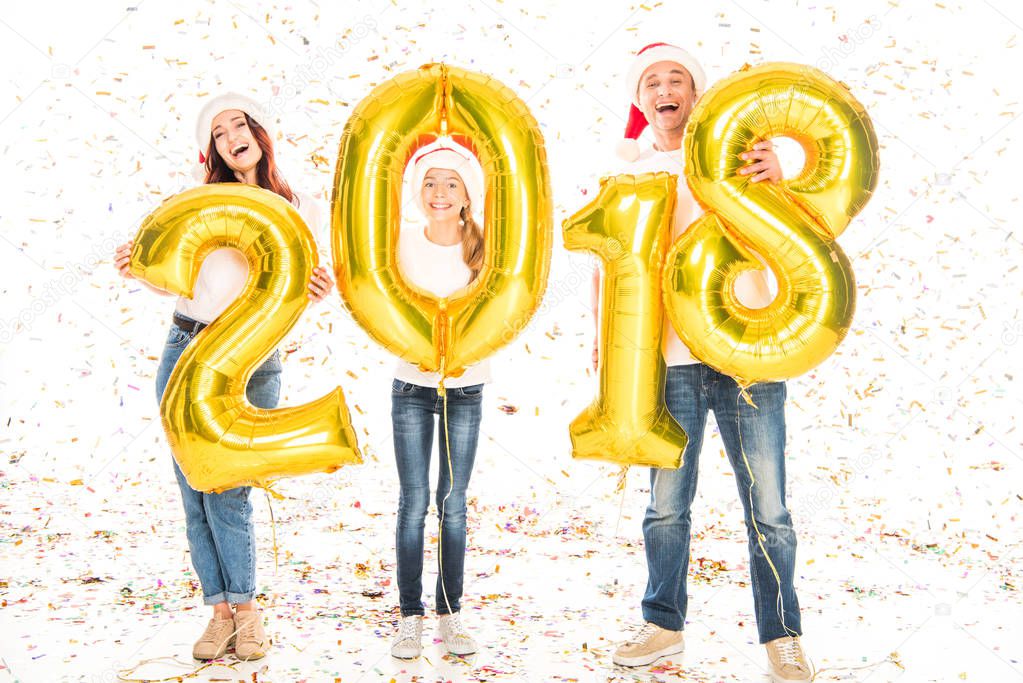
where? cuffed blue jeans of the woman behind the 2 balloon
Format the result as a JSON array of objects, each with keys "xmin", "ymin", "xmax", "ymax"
[{"xmin": 157, "ymin": 314, "xmax": 280, "ymax": 604}]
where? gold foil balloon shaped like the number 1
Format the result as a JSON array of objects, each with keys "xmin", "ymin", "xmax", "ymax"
[{"xmin": 564, "ymin": 173, "xmax": 687, "ymax": 467}]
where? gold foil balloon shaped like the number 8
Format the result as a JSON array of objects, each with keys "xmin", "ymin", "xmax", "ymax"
[{"xmin": 664, "ymin": 63, "xmax": 879, "ymax": 385}]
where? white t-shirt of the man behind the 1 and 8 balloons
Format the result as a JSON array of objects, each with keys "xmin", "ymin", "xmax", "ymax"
[{"xmin": 620, "ymin": 147, "xmax": 777, "ymax": 365}]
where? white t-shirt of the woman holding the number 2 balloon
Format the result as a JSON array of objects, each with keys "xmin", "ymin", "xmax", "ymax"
[{"xmin": 174, "ymin": 192, "xmax": 330, "ymax": 323}]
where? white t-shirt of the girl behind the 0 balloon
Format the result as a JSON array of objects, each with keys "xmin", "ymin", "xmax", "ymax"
[{"xmin": 394, "ymin": 223, "xmax": 490, "ymax": 389}]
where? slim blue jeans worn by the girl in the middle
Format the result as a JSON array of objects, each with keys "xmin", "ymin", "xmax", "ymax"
[{"xmin": 391, "ymin": 379, "xmax": 483, "ymax": 617}]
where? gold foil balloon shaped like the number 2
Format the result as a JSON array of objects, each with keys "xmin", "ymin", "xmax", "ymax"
[{"xmin": 131, "ymin": 183, "xmax": 362, "ymax": 493}]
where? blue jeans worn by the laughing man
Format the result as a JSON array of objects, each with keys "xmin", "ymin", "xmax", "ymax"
[{"xmin": 642, "ymin": 363, "xmax": 802, "ymax": 643}]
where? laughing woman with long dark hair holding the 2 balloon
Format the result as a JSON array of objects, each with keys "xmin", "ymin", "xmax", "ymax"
[{"xmin": 115, "ymin": 93, "xmax": 333, "ymax": 661}]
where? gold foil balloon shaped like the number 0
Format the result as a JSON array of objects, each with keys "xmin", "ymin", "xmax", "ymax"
[{"xmin": 330, "ymin": 64, "xmax": 553, "ymax": 376}]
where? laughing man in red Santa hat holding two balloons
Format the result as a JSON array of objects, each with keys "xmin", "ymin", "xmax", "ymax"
[{"xmin": 593, "ymin": 43, "xmax": 810, "ymax": 683}]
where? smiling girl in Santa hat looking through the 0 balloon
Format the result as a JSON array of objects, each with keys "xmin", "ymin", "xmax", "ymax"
[{"xmin": 391, "ymin": 140, "xmax": 490, "ymax": 658}]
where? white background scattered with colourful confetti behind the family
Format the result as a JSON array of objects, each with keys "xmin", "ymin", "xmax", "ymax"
[{"xmin": 0, "ymin": 0, "xmax": 1023, "ymax": 683}]
